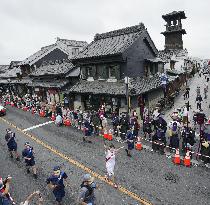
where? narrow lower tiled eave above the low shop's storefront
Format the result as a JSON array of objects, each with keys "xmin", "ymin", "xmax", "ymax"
[{"xmin": 28, "ymin": 80, "xmax": 68, "ymax": 88}]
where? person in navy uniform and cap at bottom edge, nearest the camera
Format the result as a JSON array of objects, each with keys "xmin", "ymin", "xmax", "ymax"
[{"xmin": 46, "ymin": 166, "xmax": 68, "ymax": 205}]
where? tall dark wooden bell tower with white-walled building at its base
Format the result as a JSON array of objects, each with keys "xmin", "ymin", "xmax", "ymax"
[{"xmin": 158, "ymin": 11, "xmax": 191, "ymax": 91}]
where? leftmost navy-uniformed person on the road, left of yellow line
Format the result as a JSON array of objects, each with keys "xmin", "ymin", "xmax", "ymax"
[{"xmin": 5, "ymin": 128, "xmax": 20, "ymax": 161}]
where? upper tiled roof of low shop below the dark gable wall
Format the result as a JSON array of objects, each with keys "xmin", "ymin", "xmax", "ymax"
[{"xmin": 30, "ymin": 60, "xmax": 74, "ymax": 76}]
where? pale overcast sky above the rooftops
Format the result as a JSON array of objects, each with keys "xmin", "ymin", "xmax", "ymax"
[{"xmin": 0, "ymin": 0, "xmax": 210, "ymax": 65}]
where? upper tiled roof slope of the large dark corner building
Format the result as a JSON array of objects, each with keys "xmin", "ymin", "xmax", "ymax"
[{"xmin": 74, "ymin": 23, "xmax": 154, "ymax": 59}]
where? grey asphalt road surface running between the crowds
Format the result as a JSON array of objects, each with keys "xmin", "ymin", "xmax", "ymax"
[{"xmin": 0, "ymin": 73, "xmax": 210, "ymax": 205}]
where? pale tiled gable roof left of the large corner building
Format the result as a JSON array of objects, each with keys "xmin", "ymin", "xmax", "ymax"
[{"xmin": 19, "ymin": 38, "xmax": 88, "ymax": 65}]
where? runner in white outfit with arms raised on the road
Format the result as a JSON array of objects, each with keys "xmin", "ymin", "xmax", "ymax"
[{"xmin": 104, "ymin": 144, "xmax": 124, "ymax": 188}]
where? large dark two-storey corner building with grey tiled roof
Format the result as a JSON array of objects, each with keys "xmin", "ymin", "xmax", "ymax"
[{"xmin": 69, "ymin": 23, "xmax": 164, "ymax": 113}]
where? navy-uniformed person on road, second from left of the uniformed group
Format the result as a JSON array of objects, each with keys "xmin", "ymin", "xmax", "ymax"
[{"xmin": 22, "ymin": 142, "xmax": 37, "ymax": 179}]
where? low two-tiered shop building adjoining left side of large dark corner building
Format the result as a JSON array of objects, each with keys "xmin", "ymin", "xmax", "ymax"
[{"xmin": 28, "ymin": 59, "xmax": 79, "ymax": 104}]
